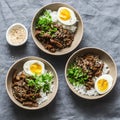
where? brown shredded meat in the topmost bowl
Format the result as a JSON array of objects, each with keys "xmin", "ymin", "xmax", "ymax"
[{"xmin": 35, "ymin": 24, "xmax": 75, "ymax": 52}]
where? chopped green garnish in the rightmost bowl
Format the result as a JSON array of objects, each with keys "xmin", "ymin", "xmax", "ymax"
[{"xmin": 67, "ymin": 65, "xmax": 88, "ymax": 86}]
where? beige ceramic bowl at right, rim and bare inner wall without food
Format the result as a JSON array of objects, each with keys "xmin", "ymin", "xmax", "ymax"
[{"xmin": 65, "ymin": 47, "xmax": 117, "ymax": 100}]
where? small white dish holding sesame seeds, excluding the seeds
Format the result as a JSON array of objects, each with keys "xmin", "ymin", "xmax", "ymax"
[{"xmin": 6, "ymin": 23, "xmax": 28, "ymax": 46}]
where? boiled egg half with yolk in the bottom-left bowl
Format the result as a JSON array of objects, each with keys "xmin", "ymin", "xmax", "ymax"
[{"xmin": 23, "ymin": 60, "xmax": 45, "ymax": 75}]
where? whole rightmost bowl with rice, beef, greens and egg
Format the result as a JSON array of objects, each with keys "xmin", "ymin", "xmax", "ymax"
[{"xmin": 65, "ymin": 48, "xmax": 116, "ymax": 99}]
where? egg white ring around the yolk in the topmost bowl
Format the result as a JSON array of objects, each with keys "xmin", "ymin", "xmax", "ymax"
[{"xmin": 57, "ymin": 7, "xmax": 77, "ymax": 25}]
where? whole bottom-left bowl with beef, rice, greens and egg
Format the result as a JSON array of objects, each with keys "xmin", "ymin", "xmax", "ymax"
[{"xmin": 6, "ymin": 56, "xmax": 58, "ymax": 110}]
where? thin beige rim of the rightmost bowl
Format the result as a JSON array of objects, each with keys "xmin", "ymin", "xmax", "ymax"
[{"xmin": 64, "ymin": 47, "xmax": 117, "ymax": 100}]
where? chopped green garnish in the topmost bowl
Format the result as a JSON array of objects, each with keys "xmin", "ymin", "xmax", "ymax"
[{"xmin": 36, "ymin": 10, "xmax": 57, "ymax": 35}]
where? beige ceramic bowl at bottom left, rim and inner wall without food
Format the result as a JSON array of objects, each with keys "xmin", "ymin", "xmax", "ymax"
[{"xmin": 5, "ymin": 56, "xmax": 59, "ymax": 110}]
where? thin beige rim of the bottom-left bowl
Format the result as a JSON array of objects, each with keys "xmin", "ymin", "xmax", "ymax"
[{"xmin": 5, "ymin": 56, "xmax": 59, "ymax": 110}]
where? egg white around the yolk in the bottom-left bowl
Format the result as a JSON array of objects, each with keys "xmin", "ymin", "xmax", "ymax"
[{"xmin": 23, "ymin": 60, "xmax": 45, "ymax": 75}]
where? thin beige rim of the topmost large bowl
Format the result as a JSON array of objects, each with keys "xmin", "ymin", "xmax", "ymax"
[{"xmin": 31, "ymin": 2, "xmax": 84, "ymax": 56}]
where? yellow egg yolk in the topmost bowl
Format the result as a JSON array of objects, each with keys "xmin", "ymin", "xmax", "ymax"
[{"xmin": 59, "ymin": 9, "xmax": 71, "ymax": 21}]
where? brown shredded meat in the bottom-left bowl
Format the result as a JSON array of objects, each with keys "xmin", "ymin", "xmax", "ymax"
[{"xmin": 12, "ymin": 71, "xmax": 41, "ymax": 107}]
